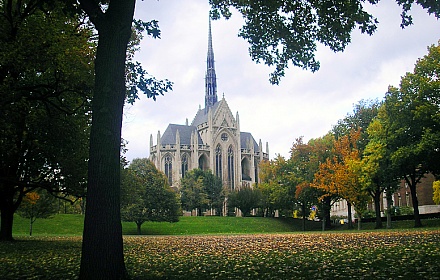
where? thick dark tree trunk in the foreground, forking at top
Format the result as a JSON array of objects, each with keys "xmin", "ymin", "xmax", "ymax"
[{"xmin": 79, "ymin": 0, "xmax": 135, "ymax": 279}]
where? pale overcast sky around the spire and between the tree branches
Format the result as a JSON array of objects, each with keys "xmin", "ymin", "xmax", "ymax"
[{"xmin": 122, "ymin": 0, "xmax": 440, "ymax": 161}]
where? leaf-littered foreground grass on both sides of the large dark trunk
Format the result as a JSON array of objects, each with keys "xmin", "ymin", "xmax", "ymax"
[{"xmin": 0, "ymin": 230, "xmax": 440, "ymax": 280}]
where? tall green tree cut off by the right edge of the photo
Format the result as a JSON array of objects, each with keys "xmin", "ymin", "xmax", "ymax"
[{"xmin": 383, "ymin": 43, "xmax": 440, "ymax": 227}]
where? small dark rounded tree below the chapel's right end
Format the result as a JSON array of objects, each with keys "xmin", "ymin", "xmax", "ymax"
[{"xmin": 228, "ymin": 186, "xmax": 261, "ymax": 217}]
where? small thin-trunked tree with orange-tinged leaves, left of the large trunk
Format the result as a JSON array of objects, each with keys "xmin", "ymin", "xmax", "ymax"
[{"xmin": 17, "ymin": 191, "xmax": 58, "ymax": 236}]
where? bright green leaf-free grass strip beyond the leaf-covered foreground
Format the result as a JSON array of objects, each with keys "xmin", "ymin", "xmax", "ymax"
[{"xmin": 13, "ymin": 214, "xmax": 440, "ymax": 236}]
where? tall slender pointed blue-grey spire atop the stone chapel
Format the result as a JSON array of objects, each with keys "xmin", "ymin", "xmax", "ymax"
[{"xmin": 205, "ymin": 17, "xmax": 217, "ymax": 114}]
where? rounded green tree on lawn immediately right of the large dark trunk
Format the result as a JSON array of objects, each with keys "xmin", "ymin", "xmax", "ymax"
[{"xmin": 121, "ymin": 158, "xmax": 180, "ymax": 234}]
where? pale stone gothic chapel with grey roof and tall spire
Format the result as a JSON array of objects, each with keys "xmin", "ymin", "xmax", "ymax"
[{"xmin": 150, "ymin": 18, "xmax": 269, "ymax": 190}]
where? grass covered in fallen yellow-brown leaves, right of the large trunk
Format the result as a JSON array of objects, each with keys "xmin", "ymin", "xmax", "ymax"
[{"xmin": 125, "ymin": 231, "xmax": 440, "ymax": 279}]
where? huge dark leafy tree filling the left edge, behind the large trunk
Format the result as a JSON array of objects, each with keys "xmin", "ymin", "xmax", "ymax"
[{"xmin": 0, "ymin": 0, "xmax": 95, "ymax": 240}]
